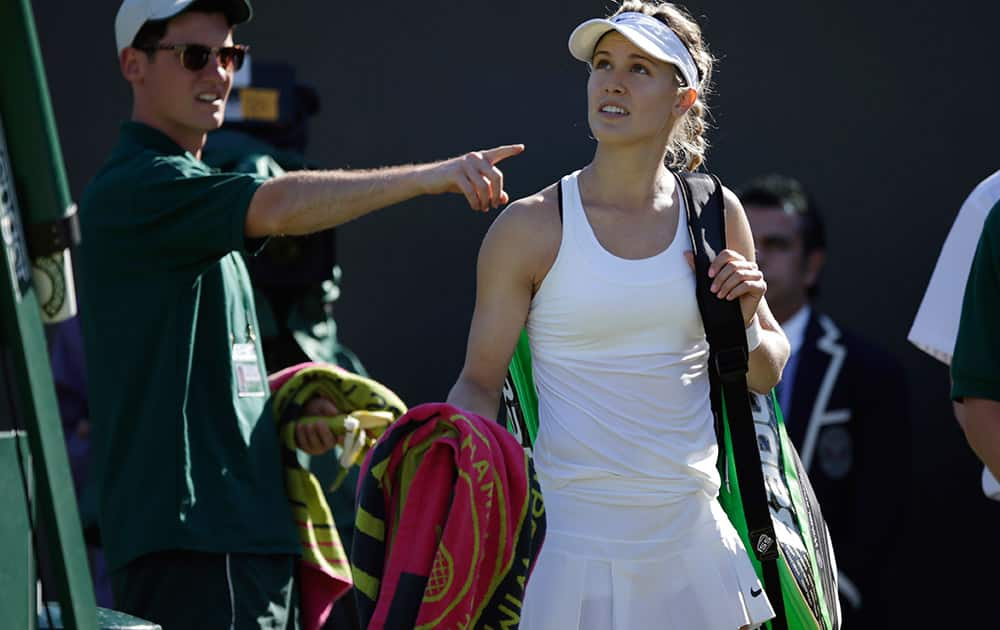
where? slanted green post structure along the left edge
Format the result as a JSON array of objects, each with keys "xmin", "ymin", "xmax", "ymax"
[{"xmin": 0, "ymin": 0, "xmax": 97, "ymax": 630}]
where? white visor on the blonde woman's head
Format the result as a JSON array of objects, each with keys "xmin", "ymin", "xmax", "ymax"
[{"xmin": 569, "ymin": 11, "xmax": 700, "ymax": 91}]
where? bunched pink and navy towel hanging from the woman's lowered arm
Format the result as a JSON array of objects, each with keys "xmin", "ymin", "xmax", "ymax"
[{"xmin": 351, "ymin": 403, "xmax": 545, "ymax": 630}]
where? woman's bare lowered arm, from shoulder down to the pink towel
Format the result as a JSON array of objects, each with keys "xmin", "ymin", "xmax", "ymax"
[{"xmin": 448, "ymin": 192, "xmax": 560, "ymax": 419}]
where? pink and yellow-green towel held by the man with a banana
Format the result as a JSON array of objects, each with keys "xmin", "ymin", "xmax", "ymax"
[{"xmin": 268, "ymin": 363, "xmax": 406, "ymax": 630}]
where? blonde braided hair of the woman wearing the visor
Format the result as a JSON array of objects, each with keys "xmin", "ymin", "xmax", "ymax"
[{"xmin": 612, "ymin": 0, "xmax": 715, "ymax": 171}]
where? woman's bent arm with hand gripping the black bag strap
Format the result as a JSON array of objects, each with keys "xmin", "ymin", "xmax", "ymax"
[{"xmin": 708, "ymin": 188, "xmax": 791, "ymax": 393}]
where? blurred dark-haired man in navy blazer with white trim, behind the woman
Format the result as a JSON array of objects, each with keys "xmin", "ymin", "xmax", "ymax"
[{"xmin": 738, "ymin": 175, "xmax": 911, "ymax": 630}]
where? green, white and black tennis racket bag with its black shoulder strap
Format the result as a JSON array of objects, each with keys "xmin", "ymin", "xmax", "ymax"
[{"xmin": 678, "ymin": 173, "xmax": 840, "ymax": 630}]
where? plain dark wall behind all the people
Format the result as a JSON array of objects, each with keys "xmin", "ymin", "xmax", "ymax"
[{"xmin": 34, "ymin": 0, "xmax": 1000, "ymax": 627}]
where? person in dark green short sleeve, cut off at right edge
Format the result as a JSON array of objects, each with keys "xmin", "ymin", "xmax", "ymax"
[{"xmin": 951, "ymin": 203, "xmax": 1000, "ymax": 486}]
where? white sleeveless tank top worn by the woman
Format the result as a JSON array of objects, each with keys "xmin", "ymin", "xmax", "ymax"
[{"xmin": 527, "ymin": 171, "xmax": 719, "ymax": 505}]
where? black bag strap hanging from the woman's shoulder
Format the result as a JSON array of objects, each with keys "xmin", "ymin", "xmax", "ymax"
[{"xmin": 677, "ymin": 173, "xmax": 788, "ymax": 630}]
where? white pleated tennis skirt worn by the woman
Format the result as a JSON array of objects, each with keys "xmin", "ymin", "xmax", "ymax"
[{"xmin": 520, "ymin": 475, "xmax": 774, "ymax": 630}]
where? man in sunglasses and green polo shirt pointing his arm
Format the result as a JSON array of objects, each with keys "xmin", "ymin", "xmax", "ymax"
[{"xmin": 79, "ymin": 0, "xmax": 523, "ymax": 630}]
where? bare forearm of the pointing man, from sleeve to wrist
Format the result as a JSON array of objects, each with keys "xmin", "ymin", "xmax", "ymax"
[{"xmin": 247, "ymin": 164, "xmax": 433, "ymax": 237}]
